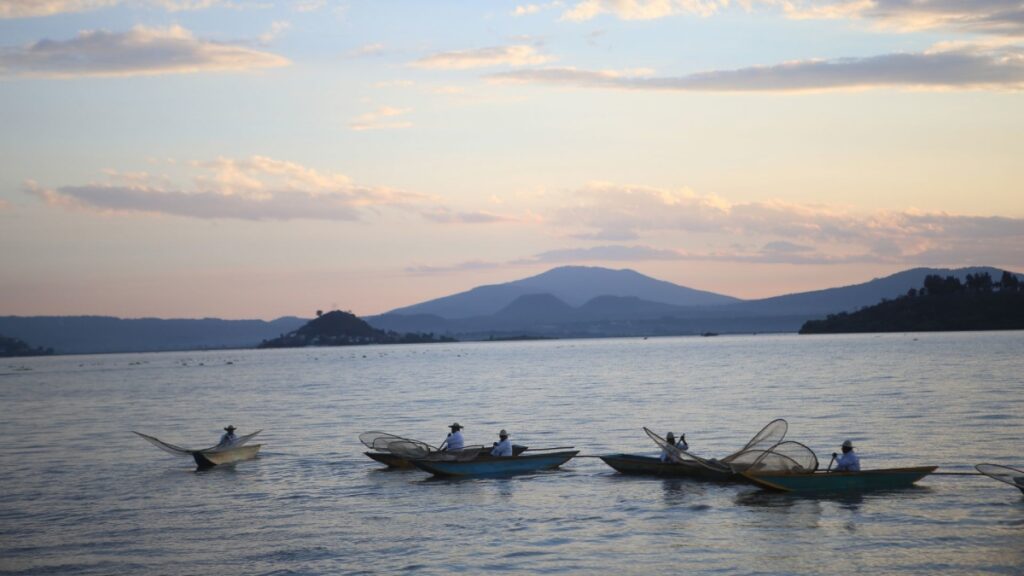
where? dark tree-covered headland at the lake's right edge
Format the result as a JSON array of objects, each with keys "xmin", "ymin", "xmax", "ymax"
[{"xmin": 800, "ymin": 272, "xmax": 1024, "ymax": 334}]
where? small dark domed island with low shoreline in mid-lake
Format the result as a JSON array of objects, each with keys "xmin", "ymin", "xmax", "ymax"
[{"xmin": 259, "ymin": 311, "xmax": 456, "ymax": 348}]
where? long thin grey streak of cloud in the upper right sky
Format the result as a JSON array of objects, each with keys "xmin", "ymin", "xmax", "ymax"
[{"xmin": 490, "ymin": 45, "xmax": 1024, "ymax": 92}]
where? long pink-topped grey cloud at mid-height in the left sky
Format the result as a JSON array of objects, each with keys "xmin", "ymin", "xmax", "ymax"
[{"xmin": 25, "ymin": 156, "xmax": 427, "ymax": 220}]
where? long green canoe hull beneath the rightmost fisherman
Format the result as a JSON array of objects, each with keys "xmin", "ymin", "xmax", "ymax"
[{"xmin": 740, "ymin": 466, "xmax": 938, "ymax": 492}]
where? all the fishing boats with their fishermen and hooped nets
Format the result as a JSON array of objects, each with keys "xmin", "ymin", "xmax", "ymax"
[{"xmin": 135, "ymin": 419, "xmax": 1024, "ymax": 493}]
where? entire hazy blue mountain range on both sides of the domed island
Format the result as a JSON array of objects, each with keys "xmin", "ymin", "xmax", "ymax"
[{"xmin": 0, "ymin": 266, "xmax": 1020, "ymax": 354}]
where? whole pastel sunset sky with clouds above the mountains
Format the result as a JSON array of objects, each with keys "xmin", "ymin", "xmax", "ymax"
[{"xmin": 0, "ymin": 0, "xmax": 1024, "ymax": 319}]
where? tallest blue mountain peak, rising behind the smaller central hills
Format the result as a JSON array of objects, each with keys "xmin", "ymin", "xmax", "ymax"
[{"xmin": 382, "ymin": 266, "xmax": 740, "ymax": 320}]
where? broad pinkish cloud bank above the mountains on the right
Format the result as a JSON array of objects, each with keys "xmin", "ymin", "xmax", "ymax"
[{"xmin": 549, "ymin": 183, "xmax": 1024, "ymax": 264}]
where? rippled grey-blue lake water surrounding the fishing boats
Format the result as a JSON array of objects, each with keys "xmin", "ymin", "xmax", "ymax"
[{"xmin": 0, "ymin": 332, "xmax": 1024, "ymax": 575}]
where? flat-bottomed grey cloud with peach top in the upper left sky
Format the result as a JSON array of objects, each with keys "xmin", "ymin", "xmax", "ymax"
[{"xmin": 0, "ymin": 26, "xmax": 290, "ymax": 78}]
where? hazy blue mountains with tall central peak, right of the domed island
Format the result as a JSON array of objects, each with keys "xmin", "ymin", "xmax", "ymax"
[{"xmin": 366, "ymin": 266, "xmax": 1019, "ymax": 339}]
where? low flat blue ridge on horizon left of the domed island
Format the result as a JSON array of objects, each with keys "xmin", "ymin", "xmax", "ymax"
[{"xmin": 0, "ymin": 316, "xmax": 306, "ymax": 354}]
